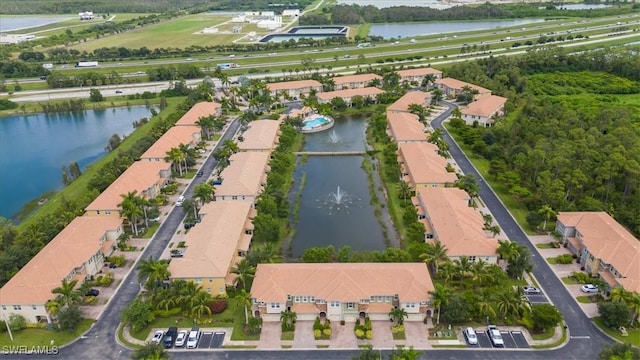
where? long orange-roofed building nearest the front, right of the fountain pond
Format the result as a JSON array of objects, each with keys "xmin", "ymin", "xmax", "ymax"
[{"xmin": 412, "ymin": 187, "xmax": 498, "ymax": 264}]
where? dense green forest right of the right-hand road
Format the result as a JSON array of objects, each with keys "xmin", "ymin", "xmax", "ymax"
[{"xmin": 447, "ymin": 48, "xmax": 640, "ymax": 236}]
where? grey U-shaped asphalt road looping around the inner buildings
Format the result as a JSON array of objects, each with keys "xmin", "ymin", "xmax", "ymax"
[{"xmin": 3, "ymin": 103, "xmax": 612, "ymax": 360}]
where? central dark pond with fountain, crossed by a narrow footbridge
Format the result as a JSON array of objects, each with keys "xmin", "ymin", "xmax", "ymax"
[{"xmin": 290, "ymin": 116, "xmax": 386, "ymax": 257}]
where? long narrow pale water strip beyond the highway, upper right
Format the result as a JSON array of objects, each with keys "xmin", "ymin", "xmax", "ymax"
[{"xmin": 369, "ymin": 19, "xmax": 544, "ymax": 39}]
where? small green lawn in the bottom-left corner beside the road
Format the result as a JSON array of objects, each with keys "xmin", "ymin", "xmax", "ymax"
[{"xmin": 0, "ymin": 319, "xmax": 94, "ymax": 347}]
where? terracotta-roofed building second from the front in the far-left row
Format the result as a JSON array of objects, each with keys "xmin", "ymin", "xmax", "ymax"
[{"xmin": 85, "ymin": 161, "xmax": 171, "ymax": 217}]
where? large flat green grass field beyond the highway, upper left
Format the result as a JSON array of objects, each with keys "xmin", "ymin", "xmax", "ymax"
[{"xmin": 71, "ymin": 14, "xmax": 249, "ymax": 51}]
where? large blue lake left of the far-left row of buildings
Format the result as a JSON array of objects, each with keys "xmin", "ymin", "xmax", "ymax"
[{"xmin": 0, "ymin": 106, "xmax": 151, "ymax": 218}]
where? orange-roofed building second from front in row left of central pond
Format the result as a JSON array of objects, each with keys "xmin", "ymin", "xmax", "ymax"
[{"xmin": 214, "ymin": 151, "xmax": 271, "ymax": 205}]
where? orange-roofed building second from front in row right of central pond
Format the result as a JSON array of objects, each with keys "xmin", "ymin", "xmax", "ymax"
[{"xmin": 398, "ymin": 141, "xmax": 458, "ymax": 191}]
